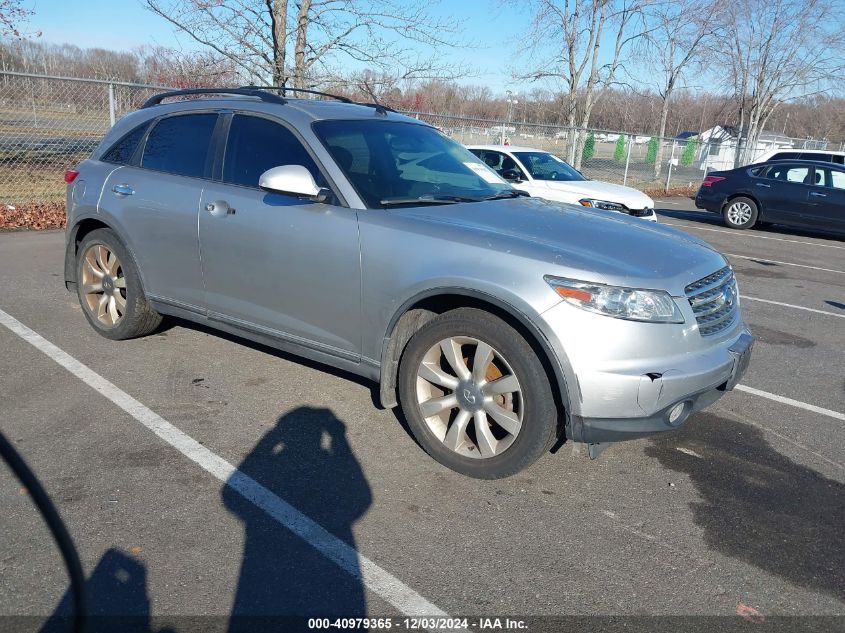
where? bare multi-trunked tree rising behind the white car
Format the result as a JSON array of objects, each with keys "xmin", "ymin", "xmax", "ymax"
[{"xmin": 519, "ymin": 0, "xmax": 646, "ymax": 168}]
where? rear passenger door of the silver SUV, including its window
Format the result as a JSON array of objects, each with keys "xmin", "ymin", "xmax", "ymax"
[{"xmin": 100, "ymin": 112, "xmax": 218, "ymax": 310}]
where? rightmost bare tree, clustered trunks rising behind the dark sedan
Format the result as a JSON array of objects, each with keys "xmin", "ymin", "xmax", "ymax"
[{"xmin": 720, "ymin": 0, "xmax": 845, "ymax": 164}]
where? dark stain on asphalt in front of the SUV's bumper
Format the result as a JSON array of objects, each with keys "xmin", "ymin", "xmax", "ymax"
[{"xmin": 646, "ymin": 413, "xmax": 845, "ymax": 599}]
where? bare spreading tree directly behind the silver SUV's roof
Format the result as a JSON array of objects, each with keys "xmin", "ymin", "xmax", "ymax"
[{"xmin": 144, "ymin": 0, "xmax": 456, "ymax": 88}]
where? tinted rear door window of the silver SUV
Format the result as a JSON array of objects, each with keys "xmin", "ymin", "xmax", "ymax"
[{"xmin": 141, "ymin": 113, "xmax": 217, "ymax": 178}]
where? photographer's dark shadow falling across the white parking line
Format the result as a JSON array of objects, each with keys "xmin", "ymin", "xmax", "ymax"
[{"xmin": 222, "ymin": 407, "xmax": 372, "ymax": 632}]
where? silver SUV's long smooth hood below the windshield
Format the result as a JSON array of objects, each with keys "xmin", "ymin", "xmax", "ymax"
[{"xmin": 389, "ymin": 198, "xmax": 727, "ymax": 296}]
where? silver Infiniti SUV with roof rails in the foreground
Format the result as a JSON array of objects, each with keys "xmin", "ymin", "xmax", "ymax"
[{"xmin": 65, "ymin": 88, "xmax": 753, "ymax": 478}]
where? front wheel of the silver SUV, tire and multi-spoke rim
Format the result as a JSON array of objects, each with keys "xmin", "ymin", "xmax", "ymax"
[{"xmin": 399, "ymin": 308, "xmax": 558, "ymax": 479}]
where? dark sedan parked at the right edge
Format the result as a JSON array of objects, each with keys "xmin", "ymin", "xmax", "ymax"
[{"xmin": 695, "ymin": 160, "xmax": 845, "ymax": 235}]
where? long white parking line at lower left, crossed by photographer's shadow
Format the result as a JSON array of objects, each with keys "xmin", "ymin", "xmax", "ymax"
[{"xmin": 0, "ymin": 310, "xmax": 448, "ymax": 617}]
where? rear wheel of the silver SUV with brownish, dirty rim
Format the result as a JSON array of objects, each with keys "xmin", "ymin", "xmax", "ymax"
[{"xmin": 76, "ymin": 229, "xmax": 161, "ymax": 341}]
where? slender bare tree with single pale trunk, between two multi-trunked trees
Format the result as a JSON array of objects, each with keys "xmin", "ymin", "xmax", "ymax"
[{"xmin": 641, "ymin": 0, "xmax": 724, "ymax": 178}]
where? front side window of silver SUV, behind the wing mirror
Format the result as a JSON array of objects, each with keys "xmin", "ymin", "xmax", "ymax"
[{"xmin": 223, "ymin": 114, "xmax": 326, "ymax": 187}]
